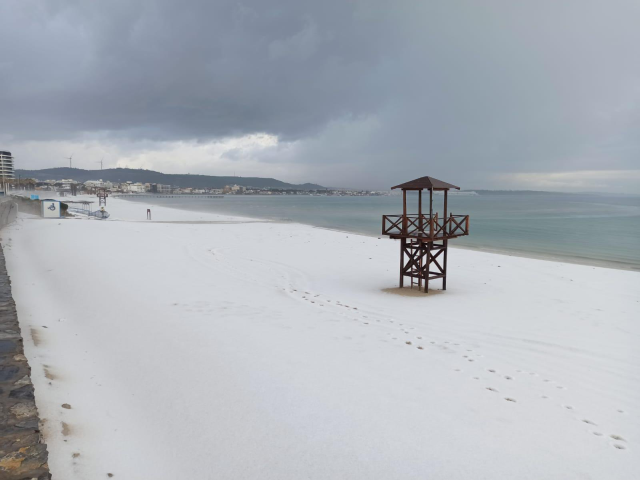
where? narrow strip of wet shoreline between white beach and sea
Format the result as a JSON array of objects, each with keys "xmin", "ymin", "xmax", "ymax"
[{"xmin": 119, "ymin": 193, "xmax": 640, "ymax": 272}]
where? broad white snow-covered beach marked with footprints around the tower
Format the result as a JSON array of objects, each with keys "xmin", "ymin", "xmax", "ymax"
[{"xmin": 1, "ymin": 199, "xmax": 640, "ymax": 480}]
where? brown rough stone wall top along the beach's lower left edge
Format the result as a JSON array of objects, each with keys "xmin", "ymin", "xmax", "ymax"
[{"xmin": 0, "ymin": 246, "xmax": 51, "ymax": 480}]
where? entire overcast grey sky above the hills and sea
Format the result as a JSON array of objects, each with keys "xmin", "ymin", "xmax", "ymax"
[{"xmin": 0, "ymin": 0, "xmax": 640, "ymax": 193}]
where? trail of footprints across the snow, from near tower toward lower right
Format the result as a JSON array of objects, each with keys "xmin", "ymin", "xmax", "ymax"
[{"xmin": 283, "ymin": 285, "xmax": 627, "ymax": 450}]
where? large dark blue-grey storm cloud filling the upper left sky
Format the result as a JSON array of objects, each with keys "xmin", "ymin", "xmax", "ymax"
[{"xmin": 2, "ymin": 1, "xmax": 379, "ymax": 139}]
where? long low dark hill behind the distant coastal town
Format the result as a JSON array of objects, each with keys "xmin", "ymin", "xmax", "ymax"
[{"xmin": 16, "ymin": 167, "xmax": 325, "ymax": 190}]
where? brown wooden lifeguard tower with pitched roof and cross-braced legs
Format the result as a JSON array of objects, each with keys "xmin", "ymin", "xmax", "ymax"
[{"xmin": 382, "ymin": 177, "xmax": 469, "ymax": 293}]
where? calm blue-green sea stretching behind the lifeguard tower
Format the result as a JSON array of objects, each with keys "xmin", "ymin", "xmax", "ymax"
[{"xmin": 124, "ymin": 193, "xmax": 640, "ymax": 270}]
